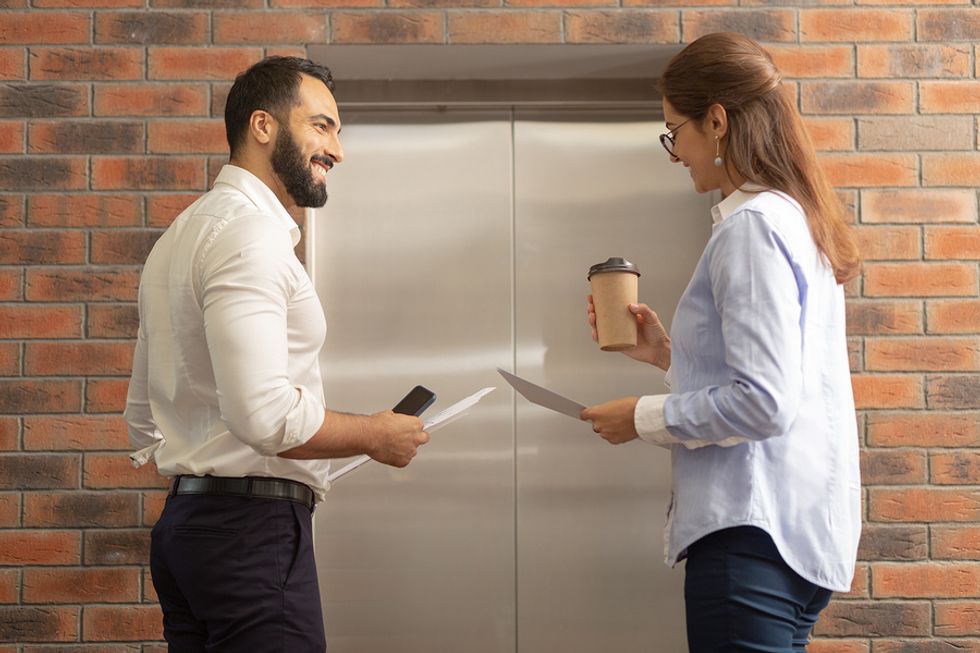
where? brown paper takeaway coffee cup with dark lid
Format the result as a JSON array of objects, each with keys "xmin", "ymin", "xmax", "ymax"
[{"xmin": 588, "ymin": 257, "xmax": 640, "ymax": 351}]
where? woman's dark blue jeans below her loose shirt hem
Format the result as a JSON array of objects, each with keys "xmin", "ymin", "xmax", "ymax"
[{"xmin": 684, "ymin": 526, "xmax": 831, "ymax": 653}]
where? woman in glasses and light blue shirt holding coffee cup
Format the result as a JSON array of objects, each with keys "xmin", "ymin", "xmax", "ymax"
[{"xmin": 582, "ymin": 33, "xmax": 861, "ymax": 653}]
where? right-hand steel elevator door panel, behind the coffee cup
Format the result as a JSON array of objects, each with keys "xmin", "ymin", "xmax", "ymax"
[{"xmin": 515, "ymin": 113, "xmax": 710, "ymax": 653}]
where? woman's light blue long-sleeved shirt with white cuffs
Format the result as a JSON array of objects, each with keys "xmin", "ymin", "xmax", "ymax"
[{"xmin": 635, "ymin": 189, "xmax": 861, "ymax": 592}]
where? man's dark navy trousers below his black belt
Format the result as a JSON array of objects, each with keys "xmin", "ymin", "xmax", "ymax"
[{"xmin": 150, "ymin": 494, "xmax": 326, "ymax": 653}]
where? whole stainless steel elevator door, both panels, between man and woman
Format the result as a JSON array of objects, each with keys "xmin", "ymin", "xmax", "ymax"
[{"xmin": 309, "ymin": 110, "xmax": 710, "ymax": 653}]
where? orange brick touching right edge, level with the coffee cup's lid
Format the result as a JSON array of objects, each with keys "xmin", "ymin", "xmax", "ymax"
[{"xmin": 864, "ymin": 263, "xmax": 977, "ymax": 297}]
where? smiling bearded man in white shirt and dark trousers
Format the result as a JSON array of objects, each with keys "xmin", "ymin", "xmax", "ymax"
[{"xmin": 126, "ymin": 57, "xmax": 428, "ymax": 653}]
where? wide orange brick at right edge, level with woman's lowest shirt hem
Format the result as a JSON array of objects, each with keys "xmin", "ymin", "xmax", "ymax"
[{"xmin": 871, "ymin": 562, "xmax": 980, "ymax": 598}]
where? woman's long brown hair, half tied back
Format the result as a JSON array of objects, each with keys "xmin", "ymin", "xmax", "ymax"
[{"xmin": 659, "ymin": 32, "xmax": 861, "ymax": 283}]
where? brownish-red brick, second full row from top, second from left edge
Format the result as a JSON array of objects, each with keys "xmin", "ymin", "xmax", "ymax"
[{"xmin": 30, "ymin": 47, "xmax": 144, "ymax": 81}]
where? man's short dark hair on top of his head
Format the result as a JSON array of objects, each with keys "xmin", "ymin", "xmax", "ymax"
[{"xmin": 225, "ymin": 57, "xmax": 333, "ymax": 156}]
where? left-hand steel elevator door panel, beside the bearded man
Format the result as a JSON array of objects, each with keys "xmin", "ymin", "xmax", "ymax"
[{"xmin": 312, "ymin": 111, "xmax": 515, "ymax": 653}]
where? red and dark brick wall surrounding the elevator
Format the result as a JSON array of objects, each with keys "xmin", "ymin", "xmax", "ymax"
[{"xmin": 0, "ymin": 0, "xmax": 980, "ymax": 653}]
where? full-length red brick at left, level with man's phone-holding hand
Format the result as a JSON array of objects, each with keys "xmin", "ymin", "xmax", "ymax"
[{"xmin": 24, "ymin": 415, "xmax": 130, "ymax": 451}]
